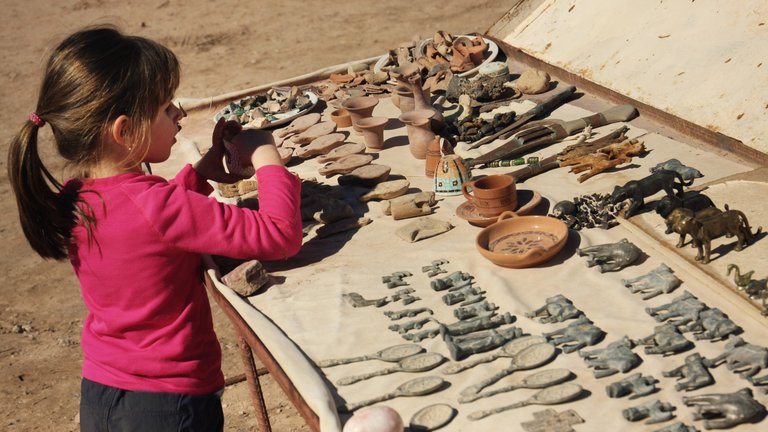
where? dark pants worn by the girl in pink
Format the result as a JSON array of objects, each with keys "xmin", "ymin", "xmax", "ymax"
[{"xmin": 80, "ymin": 378, "xmax": 224, "ymax": 432}]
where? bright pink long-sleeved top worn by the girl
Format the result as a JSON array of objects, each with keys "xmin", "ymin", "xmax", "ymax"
[{"xmin": 70, "ymin": 165, "xmax": 302, "ymax": 395}]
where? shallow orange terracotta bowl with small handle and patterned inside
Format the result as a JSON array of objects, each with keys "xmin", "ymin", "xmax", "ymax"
[{"xmin": 475, "ymin": 212, "xmax": 568, "ymax": 268}]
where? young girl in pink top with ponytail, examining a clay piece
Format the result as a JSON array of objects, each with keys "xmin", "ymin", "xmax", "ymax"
[{"xmin": 8, "ymin": 27, "xmax": 302, "ymax": 431}]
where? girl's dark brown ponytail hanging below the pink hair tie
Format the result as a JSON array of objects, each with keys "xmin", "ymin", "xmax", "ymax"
[{"xmin": 8, "ymin": 121, "xmax": 93, "ymax": 260}]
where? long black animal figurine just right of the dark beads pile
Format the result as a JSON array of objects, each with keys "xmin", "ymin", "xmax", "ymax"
[{"xmin": 610, "ymin": 170, "xmax": 692, "ymax": 218}]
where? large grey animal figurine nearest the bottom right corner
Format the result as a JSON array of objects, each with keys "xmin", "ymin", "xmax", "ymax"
[{"xmin": 683, "ymin": 387, "xmax": 765, "ymax": 429}]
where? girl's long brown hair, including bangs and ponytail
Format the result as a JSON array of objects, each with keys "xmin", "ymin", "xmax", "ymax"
[{"xmin": 8, "ymin": 26, "xmax": 180, "ymax": 260}]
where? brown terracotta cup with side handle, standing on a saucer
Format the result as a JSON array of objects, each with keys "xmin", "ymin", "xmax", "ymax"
[{"xmin": 461, "ymin": 174, "xmax": 517, "ymax": 217}]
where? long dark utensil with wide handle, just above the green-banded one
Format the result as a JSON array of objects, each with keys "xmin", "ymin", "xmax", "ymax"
[{"xmin": 467, "ymin": 105, "xmax": 637, "ymax": 167}]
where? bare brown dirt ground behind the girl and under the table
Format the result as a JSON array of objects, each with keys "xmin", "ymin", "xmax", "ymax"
[{"xmin": 0, "ymin": 0, "xmax": 511, "ymax": 431}]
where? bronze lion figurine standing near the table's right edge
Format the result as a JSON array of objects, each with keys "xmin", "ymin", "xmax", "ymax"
[{"xmin": 681, "ymin": 210, "xmax": 763, "ymax": 264}]
